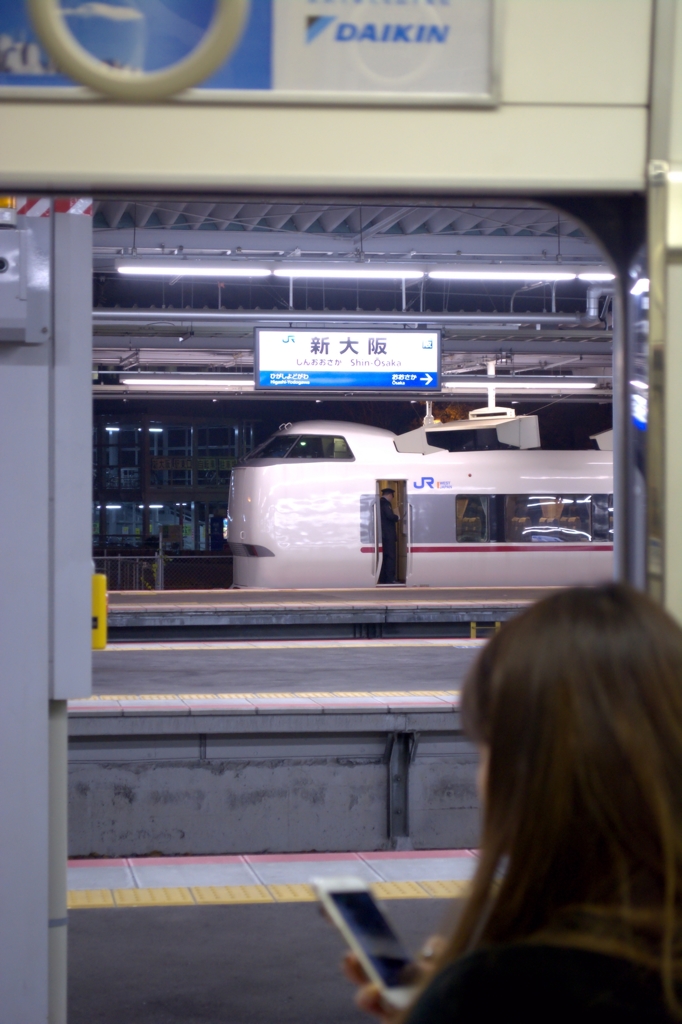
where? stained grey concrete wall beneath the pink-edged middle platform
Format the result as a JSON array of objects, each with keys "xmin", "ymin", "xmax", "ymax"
[{"xmin": 69, "ymin": 711, "xmax": 478, "ymax": 857}]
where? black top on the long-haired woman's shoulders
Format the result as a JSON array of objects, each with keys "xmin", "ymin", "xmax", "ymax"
[{"xmin": 408, "ymin": 943, "xmax": 674, "ymax": 1024}]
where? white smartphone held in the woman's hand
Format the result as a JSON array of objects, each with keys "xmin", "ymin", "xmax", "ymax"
[{"xmin": 312, "ymin": 878, "xmax": 417, "ymax": 1010}]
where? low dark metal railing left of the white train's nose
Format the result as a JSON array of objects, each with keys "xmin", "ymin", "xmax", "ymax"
[{"xmin": 94, "ymin": 554, "xmax": 232, "ymax": 590}]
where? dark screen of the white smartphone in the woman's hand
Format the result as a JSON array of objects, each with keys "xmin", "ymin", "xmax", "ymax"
[{"xmin": 330, "ymin": 892, "xmax": 411, "ymax": 988}]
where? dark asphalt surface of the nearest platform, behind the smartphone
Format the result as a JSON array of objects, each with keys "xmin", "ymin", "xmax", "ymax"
[{"xmin": 69, "ymin": 899, "xmax": 453, "ymax": 1024}]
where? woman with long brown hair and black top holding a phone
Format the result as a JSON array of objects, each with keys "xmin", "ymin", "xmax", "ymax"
[{"xmin": 347, "ymin": 585, "xmax": 682, "ymax": 1024}]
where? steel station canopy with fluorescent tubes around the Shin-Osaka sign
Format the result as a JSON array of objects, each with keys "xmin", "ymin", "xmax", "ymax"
[{"xmin": 93, "ymin": 196, "xmax": 613, "ymax": 401}]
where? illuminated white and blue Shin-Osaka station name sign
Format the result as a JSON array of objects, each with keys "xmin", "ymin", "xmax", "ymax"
[{"xmin": 256, "ymin": 329, "xmax": 440, "ymax": 393}]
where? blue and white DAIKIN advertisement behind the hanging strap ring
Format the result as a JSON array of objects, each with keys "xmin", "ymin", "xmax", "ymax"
[{"xmin": 0, "ymin": 0, "xmax": 498, "ymax": 104}]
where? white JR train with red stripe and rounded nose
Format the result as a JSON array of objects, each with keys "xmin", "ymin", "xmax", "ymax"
[{"xmin": 227, "ymin": 417, "xmax": 613, "ymax": 588}]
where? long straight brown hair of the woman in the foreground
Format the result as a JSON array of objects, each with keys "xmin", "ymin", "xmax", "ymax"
[{"xmin": 442, "ymin": 585, "xmax": 682, "ymax": 1016}]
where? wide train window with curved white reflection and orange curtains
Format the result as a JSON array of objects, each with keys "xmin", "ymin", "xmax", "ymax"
[{"xmin": 505, "ymin": 495, "xmax": 593, "ymax": 544}]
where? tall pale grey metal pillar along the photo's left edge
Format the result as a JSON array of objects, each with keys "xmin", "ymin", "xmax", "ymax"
[{"xmin": 0, "ymin": 200, "xmax": 92, "ymax": 1024}]
